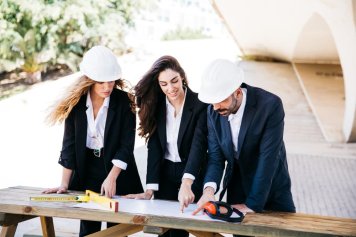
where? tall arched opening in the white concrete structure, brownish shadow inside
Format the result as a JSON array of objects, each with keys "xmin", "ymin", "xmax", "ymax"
[{"xmin": 292, "ymin": 13, "xmax": 345, "ymax": 142}]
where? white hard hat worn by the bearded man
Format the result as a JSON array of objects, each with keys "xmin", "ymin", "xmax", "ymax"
[{"xmin": 198, "ymin": 59, "xmax": 244, "ymax": 104}]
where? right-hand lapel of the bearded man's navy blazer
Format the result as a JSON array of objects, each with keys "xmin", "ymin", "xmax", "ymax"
[{"xmin": 237, "ymin": 83, "xmax": 256, "ymax": 155}]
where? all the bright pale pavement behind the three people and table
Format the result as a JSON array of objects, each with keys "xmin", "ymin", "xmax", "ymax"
[{"xmin": 0, "ymin": 39, "xmax": 356, "ymax": 237}]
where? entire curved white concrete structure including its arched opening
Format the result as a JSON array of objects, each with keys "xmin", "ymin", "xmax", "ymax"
[{"xmin": 212, "ymin": 0, "xmax": 356, "ymax": 142}]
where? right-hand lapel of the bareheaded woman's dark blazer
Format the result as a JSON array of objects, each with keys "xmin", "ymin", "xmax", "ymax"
[{"xmin": 177, "ymin": 88, "xmax": 194, "ymax": 151}]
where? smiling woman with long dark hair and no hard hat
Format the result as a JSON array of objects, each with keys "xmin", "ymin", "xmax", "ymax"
[{"xmin": 127, "ymin": 56, "xmax": 207, "ymax": 237}]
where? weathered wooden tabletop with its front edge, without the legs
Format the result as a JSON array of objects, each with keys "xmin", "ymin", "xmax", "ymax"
[{"xmin": 0, "ymin": 187, "xmax": 356, "ymax": 236}]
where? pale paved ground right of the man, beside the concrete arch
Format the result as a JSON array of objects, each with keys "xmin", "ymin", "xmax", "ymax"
[{"xmin": 239, "ymin": 62, "xmax": 356, "ymax": 218}]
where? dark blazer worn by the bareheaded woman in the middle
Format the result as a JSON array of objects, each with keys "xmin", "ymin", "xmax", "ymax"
[{"xmin": 146, "ymin": 88, "xmax": 207, "ymax": 184}]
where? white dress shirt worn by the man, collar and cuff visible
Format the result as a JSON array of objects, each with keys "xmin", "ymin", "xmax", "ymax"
[{"xmin": 204, "ymin": 88, "xmax": 247, "ymax": 192}]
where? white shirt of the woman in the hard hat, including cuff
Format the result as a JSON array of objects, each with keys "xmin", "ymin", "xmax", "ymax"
[{"xmin": 86, "ymin": 91, "xmax": 127, "ymax": 170}]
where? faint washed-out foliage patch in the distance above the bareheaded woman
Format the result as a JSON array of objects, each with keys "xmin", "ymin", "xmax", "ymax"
[{"xmin": 162, "ymin": 26, "xmax": 209, "ymax": 40}]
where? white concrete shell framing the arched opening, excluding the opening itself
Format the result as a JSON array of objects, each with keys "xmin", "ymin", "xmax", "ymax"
[{"xmin": 213, "ymin": 0, "xmax": 356, "ymax": 142}]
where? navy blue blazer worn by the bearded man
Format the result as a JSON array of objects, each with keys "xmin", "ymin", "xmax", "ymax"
[{"xmin": 204, "ymin": 83, "xmax": 295, "ymax": 212}]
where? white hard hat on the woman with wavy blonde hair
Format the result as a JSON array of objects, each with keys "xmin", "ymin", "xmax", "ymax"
[{"xmin": 79, "ymin": 45, "xmax": 122, "ymax": 82}]
